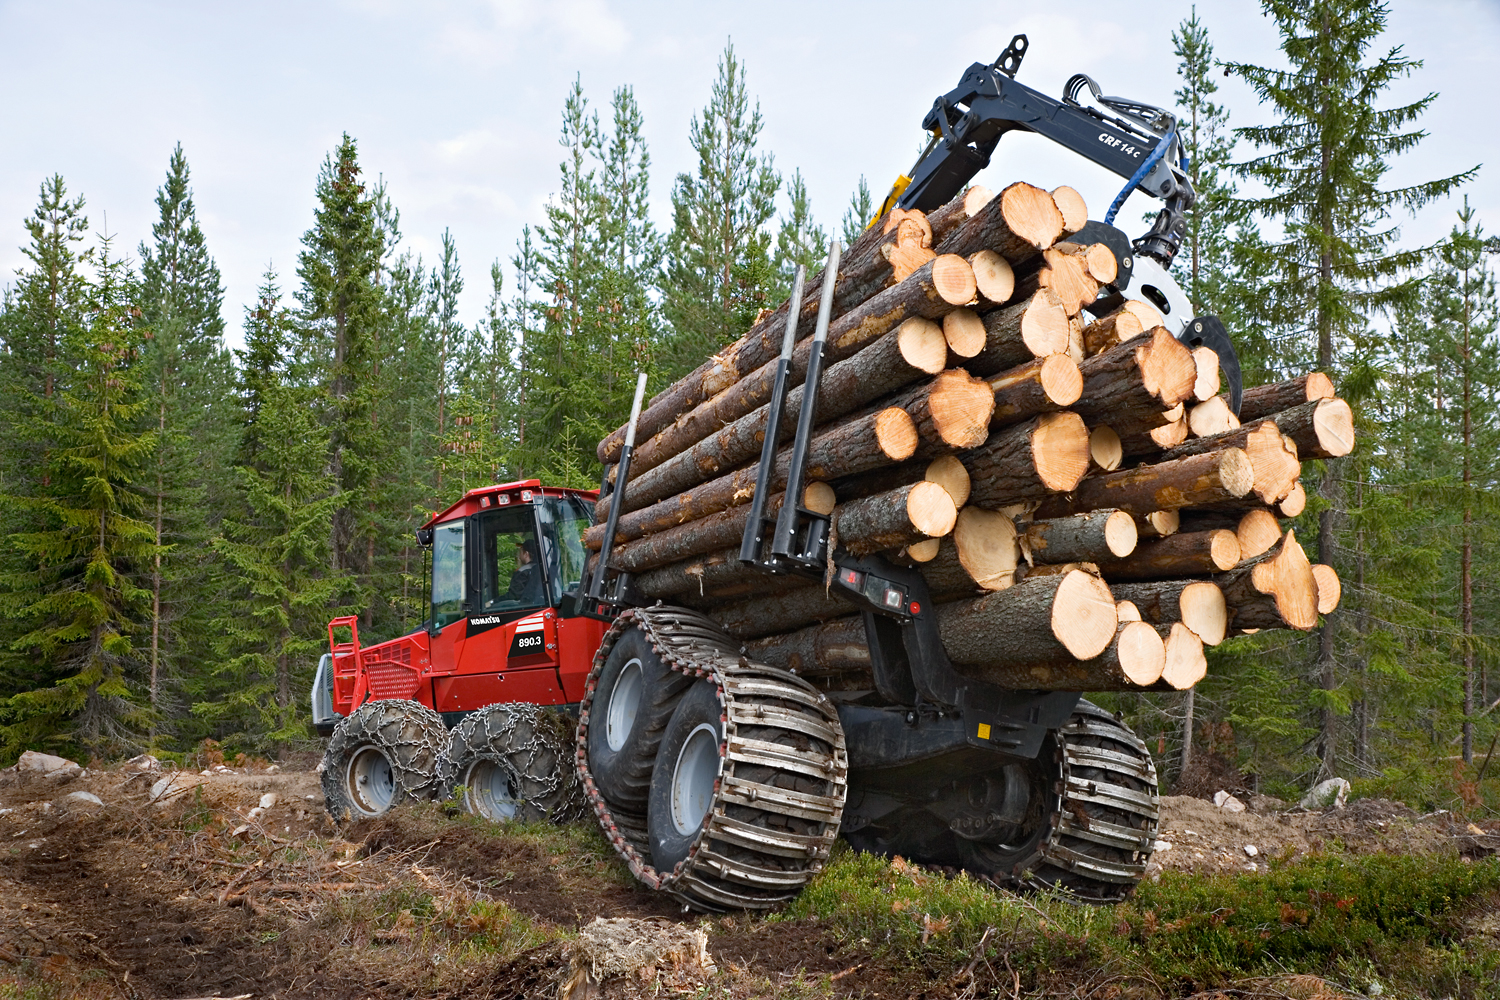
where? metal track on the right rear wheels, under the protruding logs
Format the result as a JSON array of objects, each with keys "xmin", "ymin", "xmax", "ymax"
[{"xmin": 1011, "ymin": 702, "xmax": 1161, "ymax": 903}]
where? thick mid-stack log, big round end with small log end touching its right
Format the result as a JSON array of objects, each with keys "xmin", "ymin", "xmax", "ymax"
[{"xmin": 959, "ymin": 411, "xmax": 1103, "ymax": 510}]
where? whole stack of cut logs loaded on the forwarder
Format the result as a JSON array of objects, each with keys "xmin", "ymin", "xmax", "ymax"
[{"xmin": 587, "ymin": 183, "xmax": 1353, "ymax": 691}]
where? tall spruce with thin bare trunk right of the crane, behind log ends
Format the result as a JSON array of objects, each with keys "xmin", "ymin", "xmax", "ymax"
[{"xmin": 1229, "ymin": 0, "xmax": 1472, "ymax": 775}]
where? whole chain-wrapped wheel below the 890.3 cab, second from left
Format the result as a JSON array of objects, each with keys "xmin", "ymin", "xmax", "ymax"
[{"xmin": 441, "ymin": 703, "xmax": 587, "ymax": 825}]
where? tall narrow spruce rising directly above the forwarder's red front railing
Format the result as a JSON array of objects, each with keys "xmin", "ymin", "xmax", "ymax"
[{"xmin": 297, "ymin": 133, "xmax": 386, "ymax": 599}]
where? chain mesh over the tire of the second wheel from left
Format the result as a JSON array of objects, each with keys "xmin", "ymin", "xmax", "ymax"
[{"xmin": 437, "ymin": 702, "xmax": 588, "ymax": 826}]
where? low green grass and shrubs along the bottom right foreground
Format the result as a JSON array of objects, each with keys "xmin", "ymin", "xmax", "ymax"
[{"xmin": 771, "ymin": 849, "xmax": 1500, "ymax": 1000}]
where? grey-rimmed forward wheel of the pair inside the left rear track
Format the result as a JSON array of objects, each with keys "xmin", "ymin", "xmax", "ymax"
[{"xmin": 588, "ymin": 628, "xmax": 693, "ymax": 813}]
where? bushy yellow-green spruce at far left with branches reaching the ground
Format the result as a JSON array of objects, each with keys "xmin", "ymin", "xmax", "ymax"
[{"xmin": 0, "ymin": 238, "xmax": 156, "ymax": 757}]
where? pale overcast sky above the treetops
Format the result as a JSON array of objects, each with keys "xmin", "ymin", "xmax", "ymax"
[{"xmin": 0, "ymin": 0, "xmax": 1500, "ymax": 352}]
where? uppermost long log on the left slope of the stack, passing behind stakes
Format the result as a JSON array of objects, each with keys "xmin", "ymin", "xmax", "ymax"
[{"xmin": 599, "ymin": 212, "xmax": 896, "ymax": 465}]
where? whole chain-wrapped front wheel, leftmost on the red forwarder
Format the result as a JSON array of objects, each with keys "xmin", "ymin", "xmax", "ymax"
[{"xmin": 323, "ymin": 699, "xmax": 449, "ymax": 823}]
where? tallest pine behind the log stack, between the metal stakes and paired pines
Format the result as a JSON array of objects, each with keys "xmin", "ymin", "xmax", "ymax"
[{"xmin": 662, "ymin": 43, "xmax": 782, "ymax": 381}]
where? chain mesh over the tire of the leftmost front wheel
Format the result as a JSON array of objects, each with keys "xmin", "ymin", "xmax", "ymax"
[{"xmin": 323, "ymin": 699, "xmax": 449, "ymax": 823}]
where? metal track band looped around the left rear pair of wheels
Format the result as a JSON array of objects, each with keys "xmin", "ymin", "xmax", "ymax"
[{"xmin": 576, "ymin": 606, "xmax": 849, "ymax": 910}]
